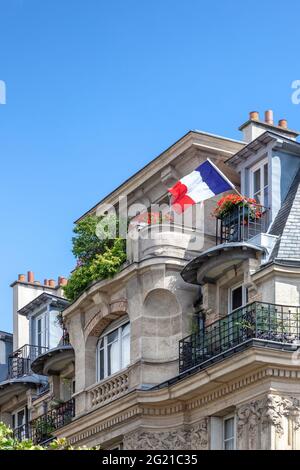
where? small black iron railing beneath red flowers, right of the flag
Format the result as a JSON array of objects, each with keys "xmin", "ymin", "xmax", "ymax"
[{"xmin": 216, "ymin": 206, "xmax": 270, "ymax": 245}]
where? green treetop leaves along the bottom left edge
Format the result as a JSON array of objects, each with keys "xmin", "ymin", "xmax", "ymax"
[{"xmin": 0, "ymin": 422, "xmax": 100, "ymax": 450}]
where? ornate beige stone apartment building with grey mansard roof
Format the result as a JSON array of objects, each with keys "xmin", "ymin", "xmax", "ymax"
[{"xmin": 0, "ymin": 111, "xmax": 300, "ymax": 450}]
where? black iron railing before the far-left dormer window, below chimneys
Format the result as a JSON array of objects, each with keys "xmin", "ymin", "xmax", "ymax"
[{"xmin": 8, "ymin": 344, "xmax": 48, "ymax": 379}]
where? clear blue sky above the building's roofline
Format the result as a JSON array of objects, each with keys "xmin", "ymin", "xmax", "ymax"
[{"xmin": 0, "ymin": 0, "xmax": 300, "ymax": 330}]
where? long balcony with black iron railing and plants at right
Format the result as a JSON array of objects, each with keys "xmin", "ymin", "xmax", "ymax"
[{"xmin": 179, "ymin": 302, "xmax": 300, "ymax": 373}]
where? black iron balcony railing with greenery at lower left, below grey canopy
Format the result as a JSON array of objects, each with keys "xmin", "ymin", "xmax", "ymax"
[{"xmin": 30, "ymin": 399, "xmax": 75, "ymax": 444}]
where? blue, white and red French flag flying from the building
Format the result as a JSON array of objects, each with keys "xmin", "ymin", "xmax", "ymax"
[{"xmin": 169, "ymin": 159, "xmax": 235, "ymax": 214}]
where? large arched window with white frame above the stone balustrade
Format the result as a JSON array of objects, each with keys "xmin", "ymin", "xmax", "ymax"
[{"xmin": 97, "ymin": 318, "xmax": 130, "ymax": 381}]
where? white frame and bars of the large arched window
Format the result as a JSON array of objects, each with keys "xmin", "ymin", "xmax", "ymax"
[{"xmin": 96, "ymin": 318, "xmax": 131, "ymax": 383}]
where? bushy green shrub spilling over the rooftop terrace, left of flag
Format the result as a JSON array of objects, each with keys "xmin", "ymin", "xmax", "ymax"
[{"xmin": 64, "ymin": 216, "xmax": 126, "ymax": 301}]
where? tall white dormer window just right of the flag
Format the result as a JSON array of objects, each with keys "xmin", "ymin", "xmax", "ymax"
[{"xmin": 250, "ymin": 160, "xmax": 269, "ymax": 207}]
